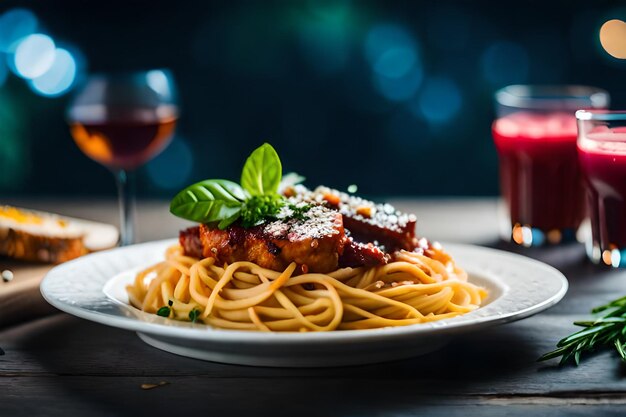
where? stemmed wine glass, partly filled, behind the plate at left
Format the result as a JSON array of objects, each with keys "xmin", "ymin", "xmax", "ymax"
[{"xmin": 67, "ymin": 69, "xmax": 178, "ymax": 246}]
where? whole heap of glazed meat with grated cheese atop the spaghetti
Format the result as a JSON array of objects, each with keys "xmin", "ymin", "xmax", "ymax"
[{"xmin": 180, "ymin": 190, "xmax": 428, "ymax": 272}]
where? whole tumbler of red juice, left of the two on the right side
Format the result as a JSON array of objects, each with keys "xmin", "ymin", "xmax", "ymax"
[{"xmin": 492, "ymin": 85, "xmax": 609, "ymax": 246}]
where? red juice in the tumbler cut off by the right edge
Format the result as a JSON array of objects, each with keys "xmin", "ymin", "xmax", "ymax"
[{"xmin": 578, "ymin": 127, "xmax": 626, "ymax": 250}]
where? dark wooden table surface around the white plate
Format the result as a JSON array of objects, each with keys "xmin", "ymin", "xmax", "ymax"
[{"xmin": 0, "ymin": 199, "xmax": 626, "ymax": 417}]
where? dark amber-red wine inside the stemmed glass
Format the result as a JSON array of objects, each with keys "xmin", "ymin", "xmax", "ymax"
[{"xmin": 70, "ymin": 106, "xmax": 177, "ymax": 170}]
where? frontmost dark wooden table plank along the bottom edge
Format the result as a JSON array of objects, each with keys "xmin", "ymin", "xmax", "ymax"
[{"xmin": 0, "ymin": 376, "xmax": 624, "ymax": 417}]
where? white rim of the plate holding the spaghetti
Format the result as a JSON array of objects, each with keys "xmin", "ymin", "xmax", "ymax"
[{"xmin": 40, "ymin": 239, "xmax": 569, "ymax": 345}]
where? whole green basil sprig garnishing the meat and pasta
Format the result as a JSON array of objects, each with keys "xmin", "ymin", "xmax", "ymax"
[{"xmin": 170, "ymin": 143, "xmax": 284, "ymax": 229}]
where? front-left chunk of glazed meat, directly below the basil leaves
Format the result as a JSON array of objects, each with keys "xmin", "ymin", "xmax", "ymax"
[{"xmin": 197, "ymin": 206, "xmax": 346, "ymax": 272}]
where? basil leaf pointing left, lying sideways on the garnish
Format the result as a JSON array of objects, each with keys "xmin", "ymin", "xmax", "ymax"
[{"xmin": 170, "ymin": 180, "xmax": 247, "ymax": 223}]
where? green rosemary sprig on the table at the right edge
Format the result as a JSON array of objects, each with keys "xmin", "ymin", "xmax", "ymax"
[{"xmin": 538, "ymin": 297, "xmax": 626, "ymax": 365}]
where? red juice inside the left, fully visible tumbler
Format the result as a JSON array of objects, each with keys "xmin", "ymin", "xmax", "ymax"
[{"xmin": 492, "ymin": 112, "xmax": 584, "ymax": 232}]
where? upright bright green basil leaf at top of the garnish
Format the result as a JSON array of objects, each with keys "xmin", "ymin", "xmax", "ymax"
[{"xmin": 241, "ymin": 143, "xmax": 283, "ymax": 195}]
